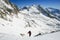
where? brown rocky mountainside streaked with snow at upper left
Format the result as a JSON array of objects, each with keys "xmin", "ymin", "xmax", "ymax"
[{"xmin": 0, "ymin": 0, "xmax": 19, "ymax": 20}]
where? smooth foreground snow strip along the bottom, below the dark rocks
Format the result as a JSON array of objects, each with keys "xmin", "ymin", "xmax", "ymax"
[{"xmin": 0, "ymin": 32, "xmax": 60, "ymax": 40}]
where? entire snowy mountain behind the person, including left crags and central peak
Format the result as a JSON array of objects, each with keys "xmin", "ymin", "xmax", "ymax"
[{"xmin": 0, "ymin": 0, "xmax": 60, "ymax": 37}]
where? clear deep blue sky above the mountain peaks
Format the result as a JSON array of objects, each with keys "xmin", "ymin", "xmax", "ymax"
[{"xmin": 10, "ymin": 0, "xmax": 60, "ymax": 9}]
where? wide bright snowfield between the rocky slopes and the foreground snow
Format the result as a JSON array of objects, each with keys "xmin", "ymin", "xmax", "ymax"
[{"xmin": 0, "ymin": 13, "xmax": 60, "ymax": 37}]
